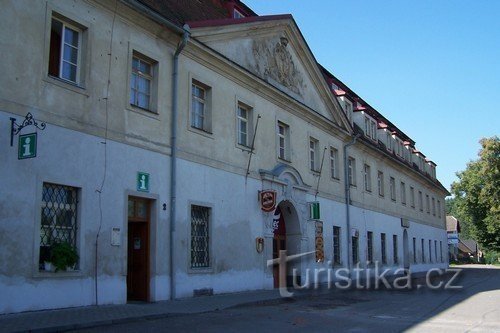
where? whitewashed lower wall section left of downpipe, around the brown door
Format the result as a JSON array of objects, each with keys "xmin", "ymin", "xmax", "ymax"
[{"xmin": 0, "ymin": 111, "xmax": 169, "ymax": 313}]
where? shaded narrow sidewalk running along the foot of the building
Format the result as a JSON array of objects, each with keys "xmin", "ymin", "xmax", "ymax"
[{"xmin": 0, "ymin": 290, "xmax": 286, "ymax": 332}]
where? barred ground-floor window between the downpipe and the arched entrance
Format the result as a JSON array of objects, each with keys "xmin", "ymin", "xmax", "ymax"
[{"xmin": 191, "ymin": 205, "xmax": 210, "ymax": 268}]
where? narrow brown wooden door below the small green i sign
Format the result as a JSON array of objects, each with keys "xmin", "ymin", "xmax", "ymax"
[{"xmin": 127, "ymin": 198, "xmax": 149, "ymax": 301}]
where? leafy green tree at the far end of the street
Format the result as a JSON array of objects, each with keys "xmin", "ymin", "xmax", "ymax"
[{"xmin": 450, "ymin": 136, "xmax": 500, "ymax": 251}]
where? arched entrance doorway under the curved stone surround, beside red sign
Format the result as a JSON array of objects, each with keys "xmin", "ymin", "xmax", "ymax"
[{"xmin": 272, "ymin": 200, "xmax": 301, "ymax": 288}]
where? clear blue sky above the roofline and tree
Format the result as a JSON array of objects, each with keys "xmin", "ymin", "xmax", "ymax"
[{"xmin": 243, "ymin": 0, "xmax": 500, "ymax": 189}]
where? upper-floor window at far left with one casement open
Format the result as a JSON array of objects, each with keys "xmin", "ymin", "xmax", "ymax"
[{"xmin": 49, "ymin": 17, "xmax": 82, "ymax": 84}]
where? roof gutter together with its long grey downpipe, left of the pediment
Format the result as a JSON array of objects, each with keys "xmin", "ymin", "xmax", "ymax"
[{"xmin": 120, "ymin": 0, "xmax": 190, "ymax": 300}]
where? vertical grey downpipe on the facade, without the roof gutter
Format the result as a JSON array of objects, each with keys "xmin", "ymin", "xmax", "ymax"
[{"xmin": 169, "ymin": 24, "xmax": 189, "ymax": 300}]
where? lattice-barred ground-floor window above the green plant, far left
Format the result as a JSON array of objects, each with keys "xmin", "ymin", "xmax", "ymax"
[{"xmin": 39, "ymin": 183, "xmax": 78, "ymax": 269}]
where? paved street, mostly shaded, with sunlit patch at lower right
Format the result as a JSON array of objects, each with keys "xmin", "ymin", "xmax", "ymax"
[{"xmin": 71, "ymin": 265, "xmax": 500, "ymax": 333}]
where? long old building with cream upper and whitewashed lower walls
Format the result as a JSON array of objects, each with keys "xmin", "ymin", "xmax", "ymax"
[{"xmin": 0, "ymin": 0, "xmax": 448, "ymax": 313}]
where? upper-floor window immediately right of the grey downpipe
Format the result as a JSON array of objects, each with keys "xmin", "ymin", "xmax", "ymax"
[{"xmin": 191, "ymin": 80, "xmax": 211, "ymax": 132}]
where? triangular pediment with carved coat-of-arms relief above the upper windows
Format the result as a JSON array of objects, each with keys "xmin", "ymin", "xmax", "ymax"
[{"xmin": 191, "ymin": 15, "xmax": 350, "ymax": 131}]
